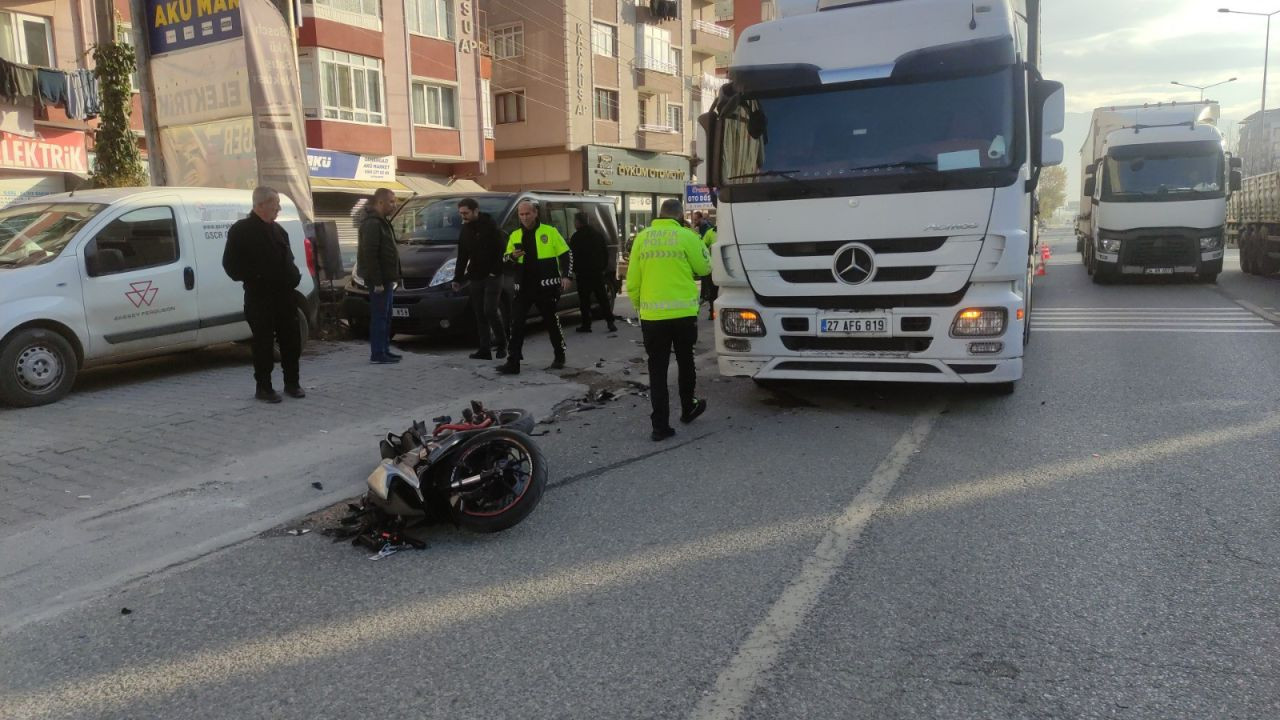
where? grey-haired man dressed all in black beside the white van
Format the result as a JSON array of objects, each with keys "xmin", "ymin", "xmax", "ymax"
[{"xmin": 223, "ymin": 187, "xmax": 307, "ymax": 402}]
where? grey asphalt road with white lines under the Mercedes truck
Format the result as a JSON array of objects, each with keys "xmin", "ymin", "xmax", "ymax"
[{"xmin": 0, "ymin": 226, "xmax": 1280, "ymax": 720}]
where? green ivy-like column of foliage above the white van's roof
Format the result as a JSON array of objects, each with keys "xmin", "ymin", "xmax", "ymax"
[{"xmin": 92, "ymin": 42, "xmax": 148, "ymax": 187}]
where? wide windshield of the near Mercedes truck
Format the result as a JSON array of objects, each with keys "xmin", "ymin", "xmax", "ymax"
[{"xmin": 721, "ymin": 68, "xmax": 1019, "ymax": 192}]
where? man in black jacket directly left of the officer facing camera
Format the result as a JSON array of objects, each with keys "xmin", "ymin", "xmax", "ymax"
[{"xmin": 453, "ymin": 197, "xmax": 507, "ymax": 360}]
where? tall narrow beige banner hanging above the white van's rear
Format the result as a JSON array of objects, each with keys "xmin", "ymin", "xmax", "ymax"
[{"xmin": 239, "ymin": 0, "xmax": 315, "ymax": 223}]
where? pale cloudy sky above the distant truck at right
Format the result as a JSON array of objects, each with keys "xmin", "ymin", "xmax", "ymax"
[{"xmin": 1043, "ymin": 0, "xmax": 1280, "ymax": 193}]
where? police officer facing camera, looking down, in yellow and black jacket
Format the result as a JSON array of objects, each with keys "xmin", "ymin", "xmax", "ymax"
[{"xmin": 498, "ymin": 200, "xmax": 573, "ymax": 375}]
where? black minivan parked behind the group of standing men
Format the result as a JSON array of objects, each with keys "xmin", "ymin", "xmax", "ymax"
[{"xmin": 342, "ymin": 191, "xmax": 620, "ymax": 336}]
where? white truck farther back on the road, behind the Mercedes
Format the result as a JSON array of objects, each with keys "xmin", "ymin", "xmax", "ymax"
[{"xmin": 1075, "ymin": 101, "xmax": 1240, "ymax": 283}]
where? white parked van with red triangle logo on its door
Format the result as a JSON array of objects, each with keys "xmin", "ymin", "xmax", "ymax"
[{"xmin": 0, "ymin": 187, "xmax": 316, "ymax": 406}]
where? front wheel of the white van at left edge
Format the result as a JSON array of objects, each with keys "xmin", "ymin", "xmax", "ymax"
[{"xmin": 0, "ymin": 328, "xmax": 79, "ymax": 407}]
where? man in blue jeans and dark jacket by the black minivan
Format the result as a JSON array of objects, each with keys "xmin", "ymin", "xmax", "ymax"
[{"xmin": 356, "ymin": 187, "xmax": 401, "ymax": 365}]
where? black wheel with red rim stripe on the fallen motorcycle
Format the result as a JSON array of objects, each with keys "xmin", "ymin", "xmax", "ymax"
[{"xmin": 445, "ymin": 428, "xmax": 547, "ymax": 533}]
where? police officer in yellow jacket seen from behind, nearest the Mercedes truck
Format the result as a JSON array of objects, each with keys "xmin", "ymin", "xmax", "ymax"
[{"xmin": 627, "ymin": 200, "xmax": 712, "ymax": 441}]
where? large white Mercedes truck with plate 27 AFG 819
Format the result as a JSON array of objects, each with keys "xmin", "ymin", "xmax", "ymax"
[{"xmin": 701, "ymin": 0, "xmax": 1065, "ymax": 392}]
